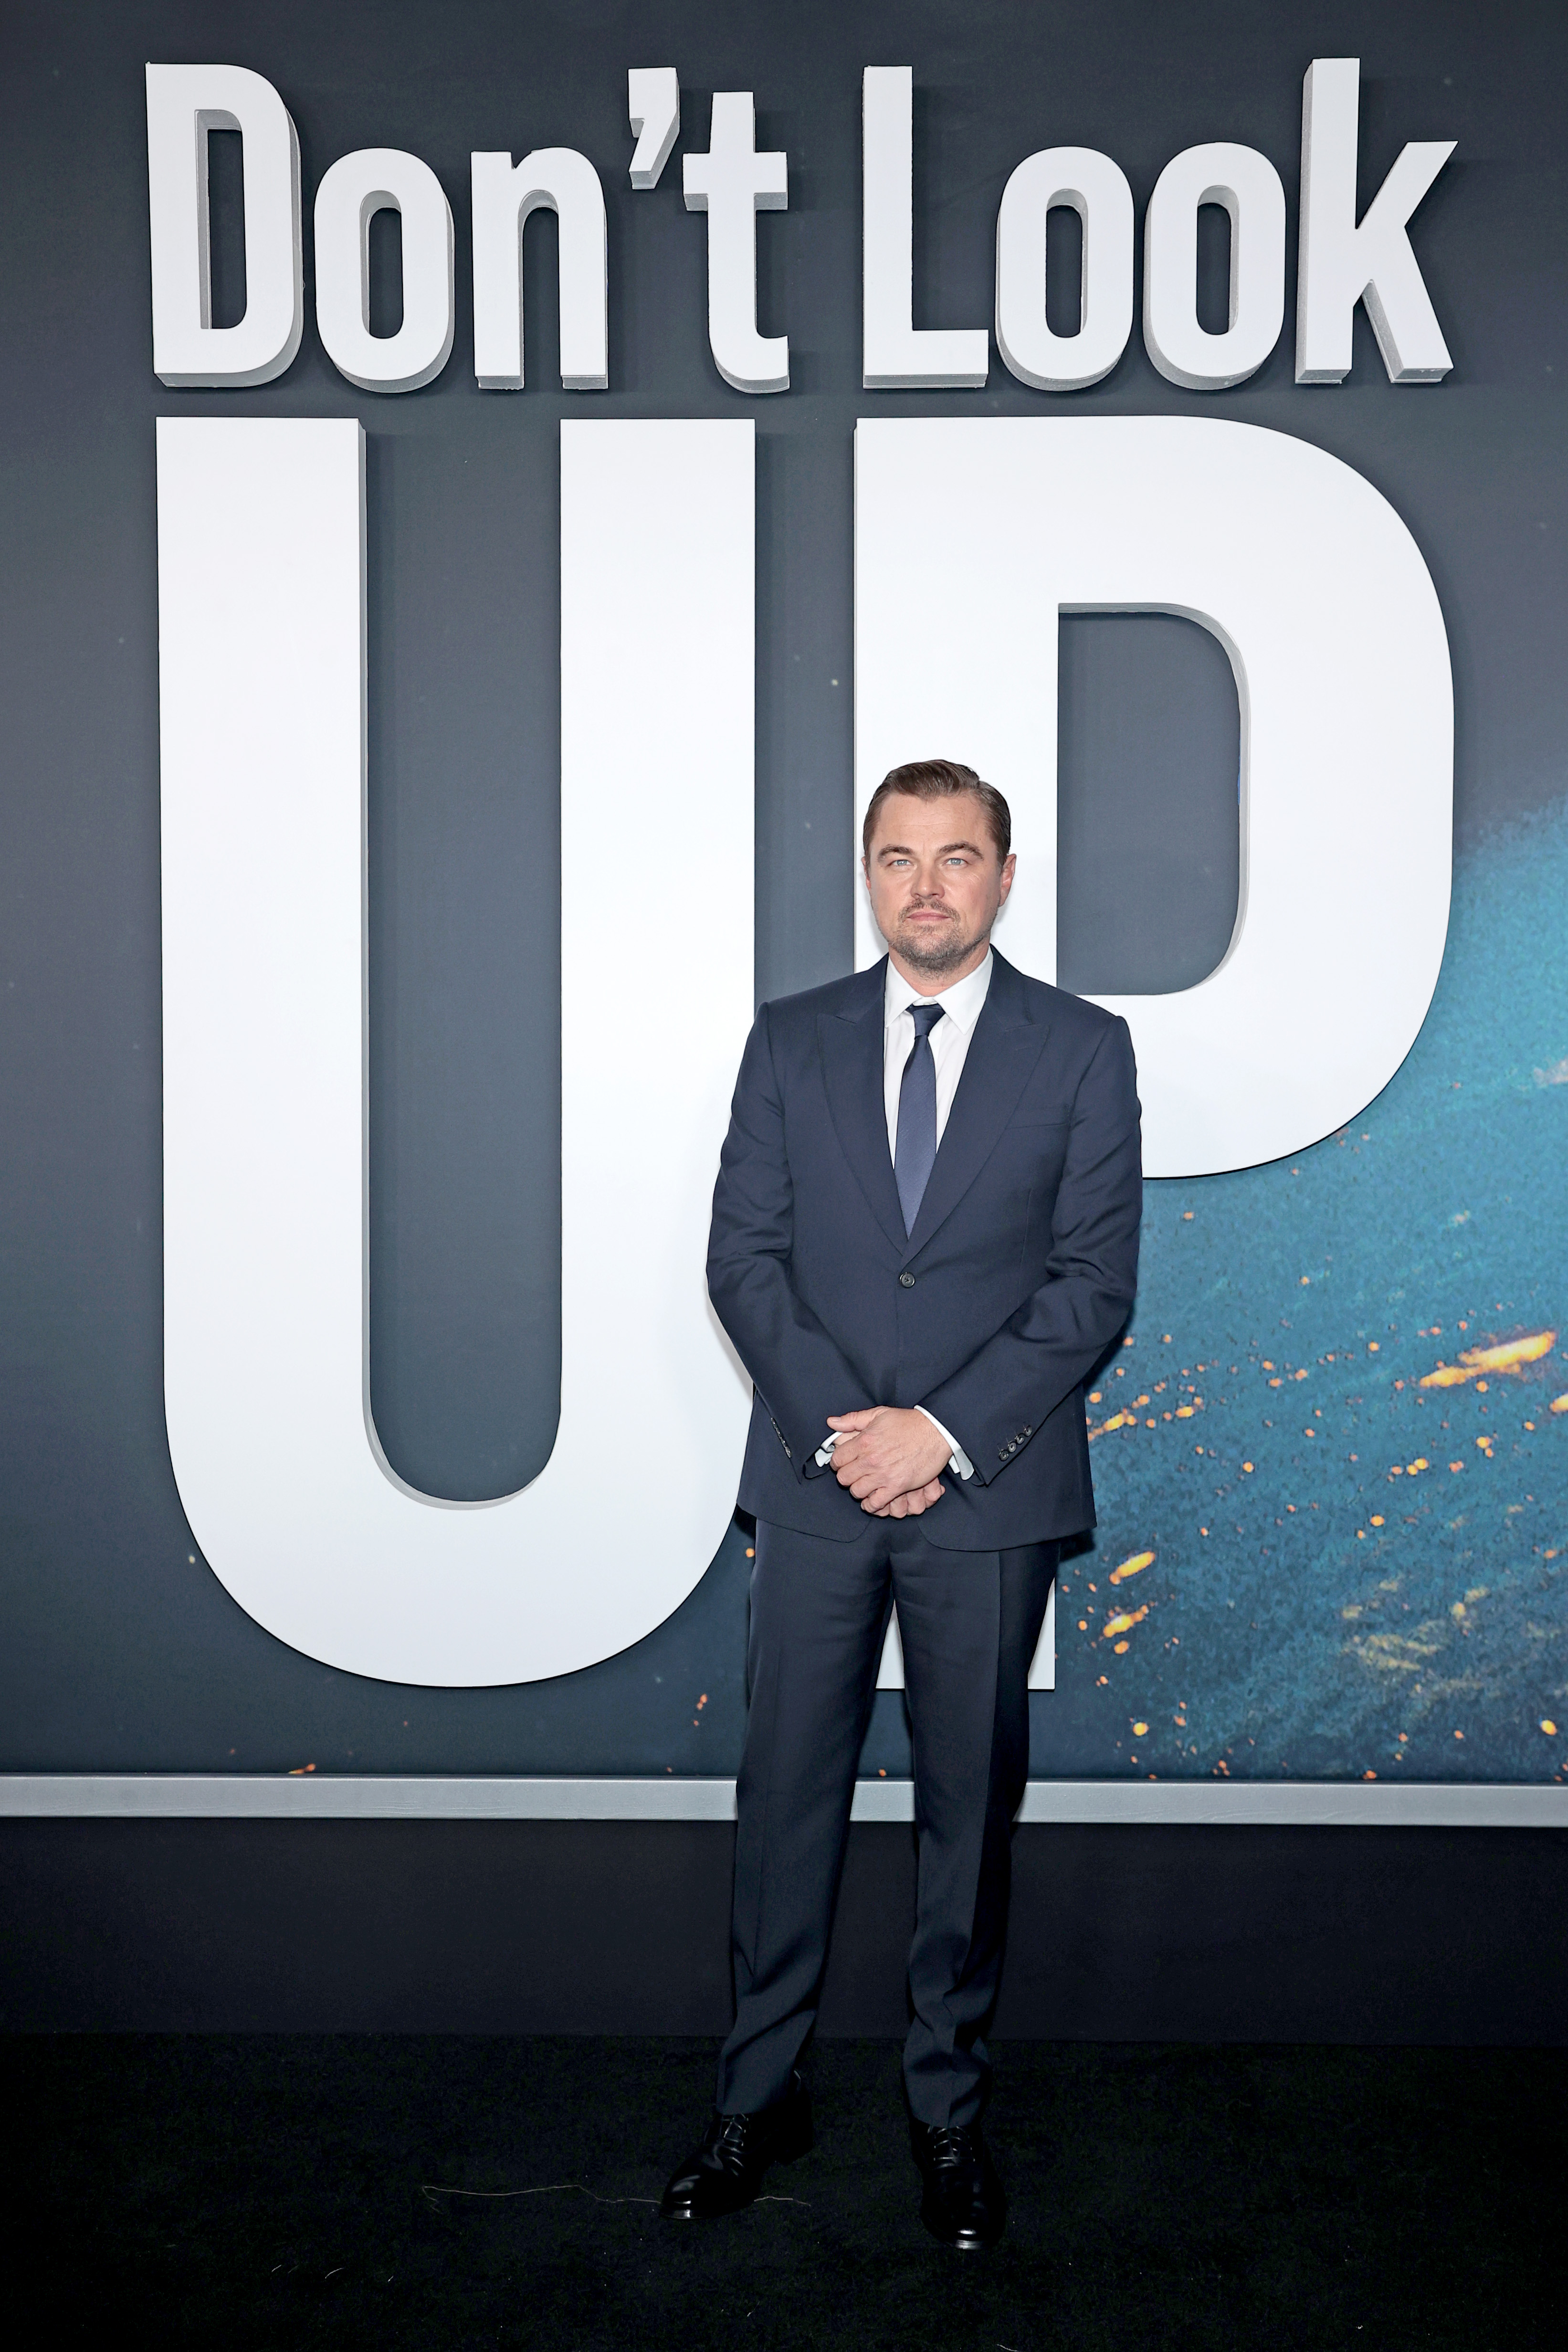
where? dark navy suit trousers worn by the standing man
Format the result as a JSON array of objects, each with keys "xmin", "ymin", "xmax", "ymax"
[{"xmin": 717, "ymin": 1503, "xmax": 1060, "ymax": 2126}]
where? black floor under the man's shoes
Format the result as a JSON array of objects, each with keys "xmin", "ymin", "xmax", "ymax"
[{"xmin": 15, "ymin": 2037, "xmax": 1568, "ymax": 2352}]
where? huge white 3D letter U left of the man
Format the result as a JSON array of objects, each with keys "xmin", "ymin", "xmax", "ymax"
[{"xmin": 158, "ymin": 416, "xmax": 755, "ymax": 1687}]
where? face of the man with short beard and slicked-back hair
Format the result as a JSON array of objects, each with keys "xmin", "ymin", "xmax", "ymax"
[{"xmin": 865, "ymin": 792, "xmax": 1013, "ymax": 979}]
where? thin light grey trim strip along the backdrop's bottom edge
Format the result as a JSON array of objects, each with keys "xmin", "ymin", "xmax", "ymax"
[{"xmin": 0, "ymin": 1773, "xmax": 1568, "ymax": 1830}]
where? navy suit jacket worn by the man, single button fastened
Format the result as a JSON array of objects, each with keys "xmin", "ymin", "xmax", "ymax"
[{"xmin": 707, "ymin": 955, "xmax": 1143, "ymax": 1552}]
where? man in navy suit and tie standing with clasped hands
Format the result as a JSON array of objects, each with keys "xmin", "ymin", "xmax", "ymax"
[{"xmin": 663, "ymin": 759, "xmax": 1143, "ymax": 2248}]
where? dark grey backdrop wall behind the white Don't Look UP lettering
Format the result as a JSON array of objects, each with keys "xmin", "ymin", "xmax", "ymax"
[{"xmin": 0, "ymin": 0, "xmax": 1568, "ymax": 1771}]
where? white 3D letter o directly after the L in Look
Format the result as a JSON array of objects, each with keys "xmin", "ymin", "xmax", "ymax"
[{"xmin": 997, "ymin": 148, "xmax": 1133, "ymax": 393}]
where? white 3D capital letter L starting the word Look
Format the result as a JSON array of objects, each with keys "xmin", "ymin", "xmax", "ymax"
[{"xmin": 861, "ymin": 66, "xmax": 989, "ymax": 393}]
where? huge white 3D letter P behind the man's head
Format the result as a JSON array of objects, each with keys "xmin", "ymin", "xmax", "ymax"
[{"xmin": 856, "ymin": 416, "xmax": 1453, "ymax": 1176}]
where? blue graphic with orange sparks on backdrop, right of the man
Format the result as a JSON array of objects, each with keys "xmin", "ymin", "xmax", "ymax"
[{"xmin": 1032, "ymin": 802, "xmax": 1568, "ymax": 1781}]
